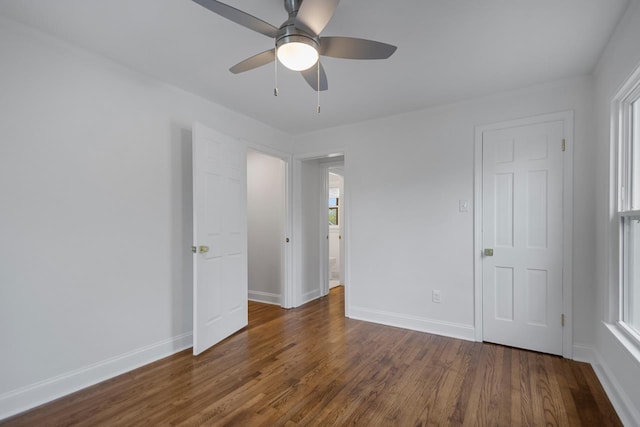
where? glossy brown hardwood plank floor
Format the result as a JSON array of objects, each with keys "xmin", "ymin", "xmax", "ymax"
[{"xmin": 0, "ymin": 288, "xmax": 621, "ymax": 426}]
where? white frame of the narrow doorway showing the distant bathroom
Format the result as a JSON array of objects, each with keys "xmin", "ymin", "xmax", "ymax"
[{"xmin": 288, "ymin": 148, "xmax": 350, "ymax": 317}]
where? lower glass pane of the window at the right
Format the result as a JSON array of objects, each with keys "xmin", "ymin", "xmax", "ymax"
[{"xmin": 622, "ymin": 218, "xmax": 640, "ymax": 333}]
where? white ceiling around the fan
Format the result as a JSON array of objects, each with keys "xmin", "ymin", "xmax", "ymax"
[{"xmin": 0, "ymin": 0, "xmax": 629, "ymax": 134}]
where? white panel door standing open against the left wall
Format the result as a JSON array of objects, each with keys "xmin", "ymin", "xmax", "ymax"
[{"xmin": 193, "ymin": 123, "xmax": 248, "ymax": 354}]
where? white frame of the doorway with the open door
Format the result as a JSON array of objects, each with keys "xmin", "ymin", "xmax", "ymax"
[{"xmin": 246, "ymin": 142, "xmax": 294, "ymax": 308}]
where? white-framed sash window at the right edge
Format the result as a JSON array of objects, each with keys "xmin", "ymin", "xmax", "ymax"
[{"xmin": 614, "ymin": 70, "xmax": 640, "ymax": 341}]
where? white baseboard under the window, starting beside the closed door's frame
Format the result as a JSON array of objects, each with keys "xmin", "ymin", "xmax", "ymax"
[{"xmin": 573, "ymin": 344, "xmax": 640, "ymax": 426}]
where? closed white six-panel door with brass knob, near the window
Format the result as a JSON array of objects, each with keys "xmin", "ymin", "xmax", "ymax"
[{"xmin": 482, "ymin": 121, "xmax": 564, "ymax": 355}]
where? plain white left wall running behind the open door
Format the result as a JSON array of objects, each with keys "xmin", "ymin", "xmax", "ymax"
[{"xmin": 0, "ymin": 20, "xmax": 291, "ymax": 418}]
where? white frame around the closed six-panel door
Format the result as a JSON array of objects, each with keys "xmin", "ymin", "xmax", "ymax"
[{"xmin": 473, "ymin": 111, "xmax": 574, "ymax": 359}]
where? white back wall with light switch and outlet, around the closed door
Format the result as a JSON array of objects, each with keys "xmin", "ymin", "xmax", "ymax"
[{"xmin": 294, "ymin": 77, "xmax": 595, "ymax": 343}]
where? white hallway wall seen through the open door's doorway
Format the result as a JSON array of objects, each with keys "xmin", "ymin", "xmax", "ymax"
[{"xmin": 247, "ymin": 150, "xmax": 285, "ymax": 305}]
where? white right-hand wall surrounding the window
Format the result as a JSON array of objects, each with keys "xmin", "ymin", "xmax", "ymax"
[{"xmin": 590, "ymin": 0, "xmax": 640, "ymax": 425}]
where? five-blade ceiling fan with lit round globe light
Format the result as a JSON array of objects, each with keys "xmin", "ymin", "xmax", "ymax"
[{"xmin": 193, "ymin": 0, "xmax": 396, "ymax": 94}]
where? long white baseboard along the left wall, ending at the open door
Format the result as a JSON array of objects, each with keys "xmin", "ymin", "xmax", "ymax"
[{"xmin": 0, "ymin": 332, "xmax": 193, "ymax": 420}]
